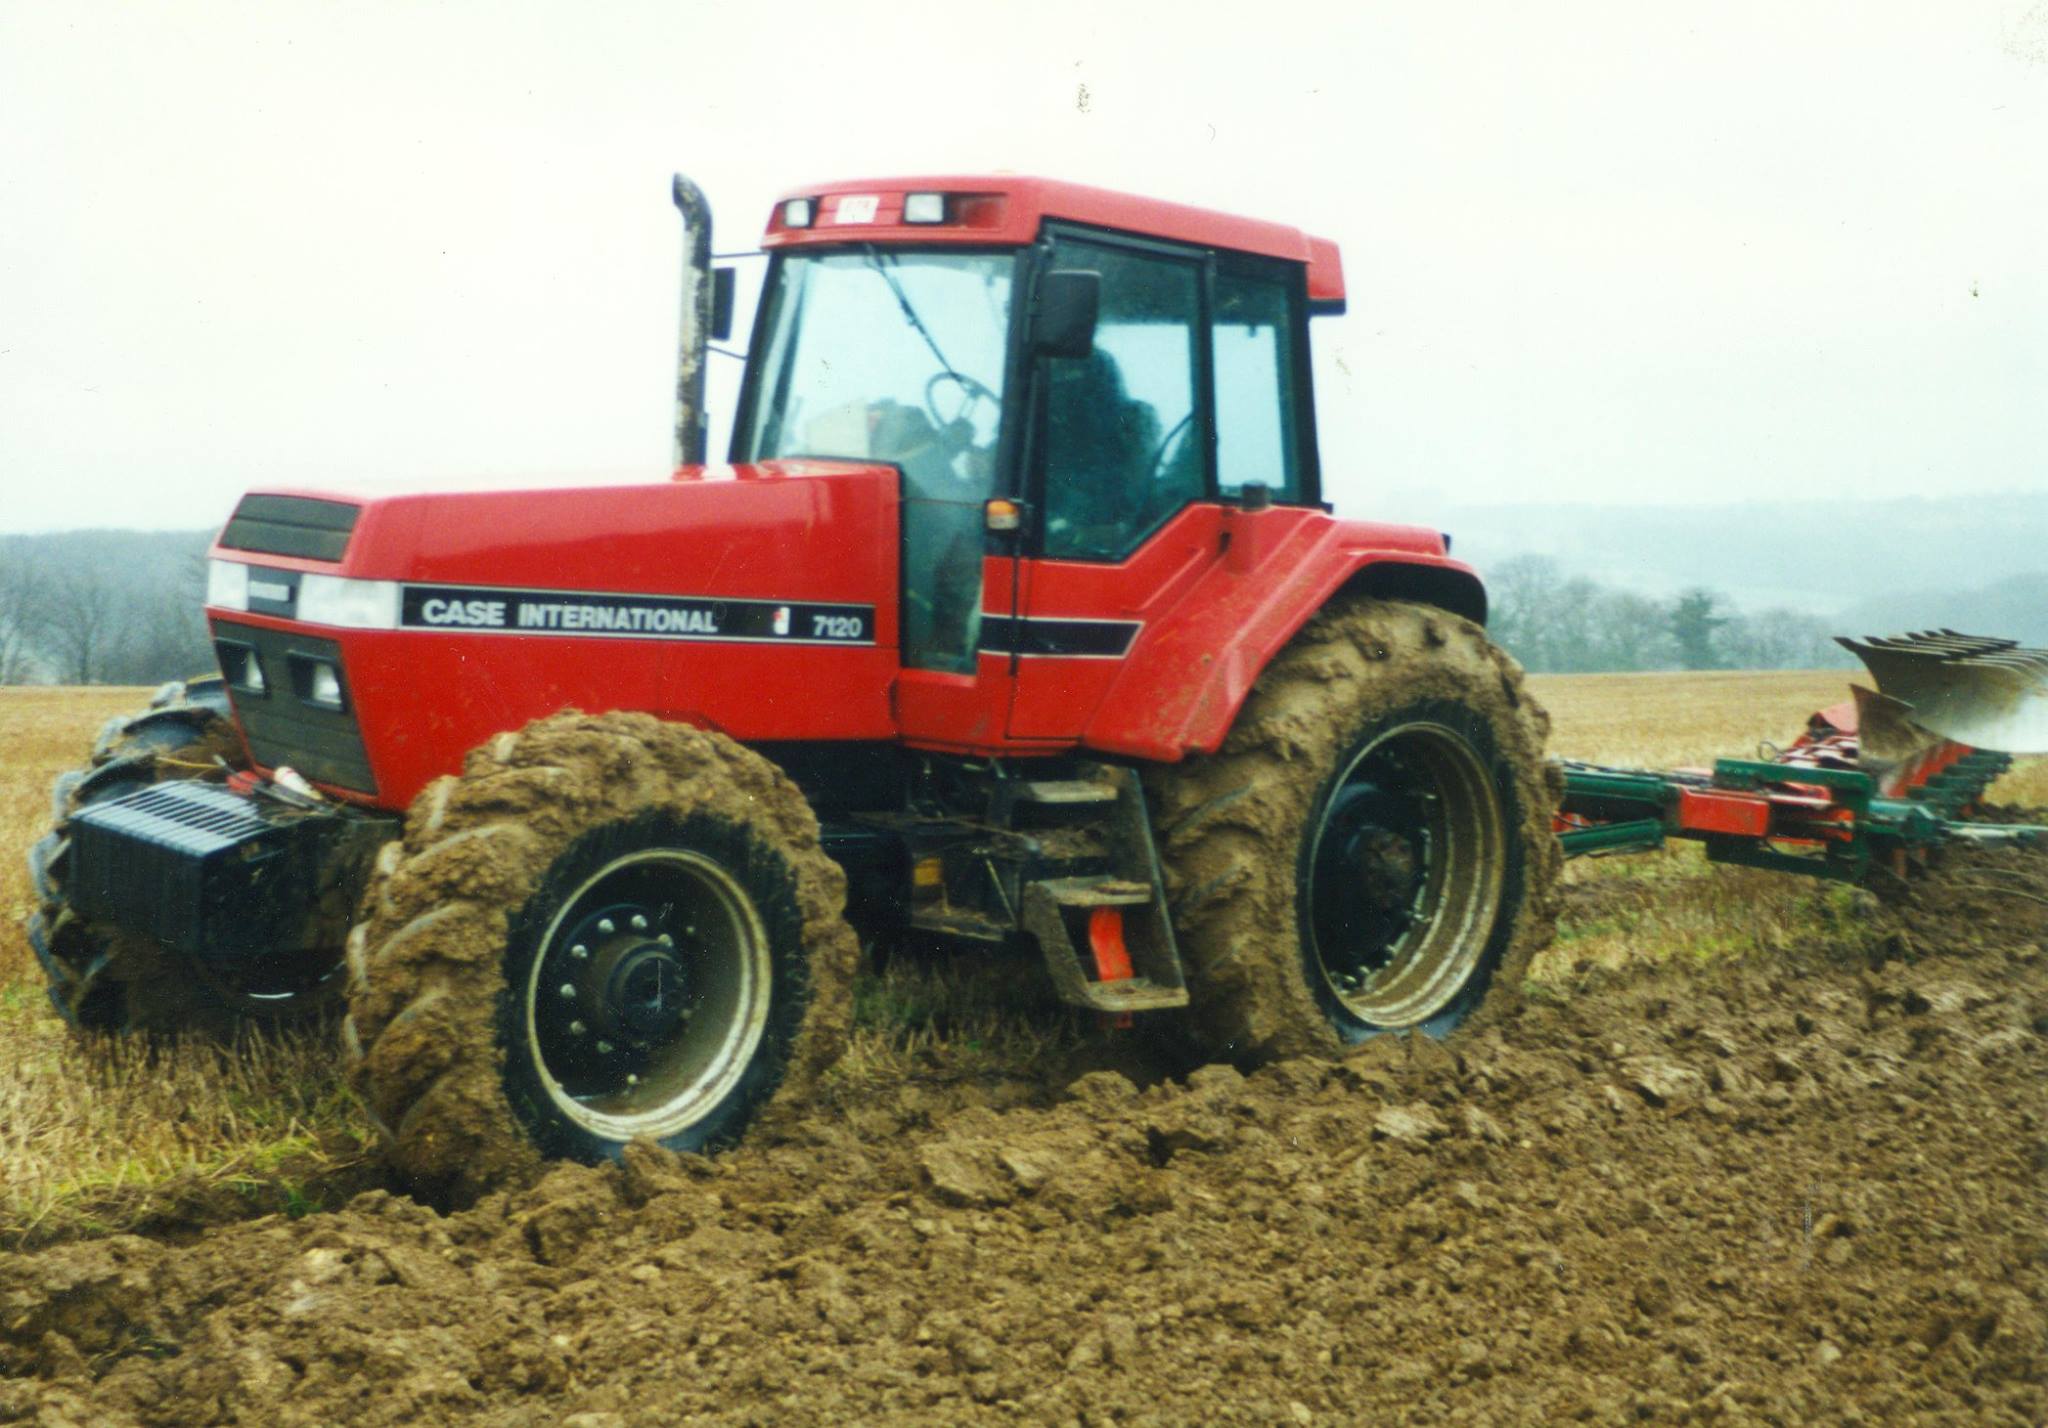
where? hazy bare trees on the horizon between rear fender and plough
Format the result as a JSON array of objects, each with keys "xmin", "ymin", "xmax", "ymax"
[{"xmin": 1485, "ymin": 555, "xmax": 1847, "ymax": 674}]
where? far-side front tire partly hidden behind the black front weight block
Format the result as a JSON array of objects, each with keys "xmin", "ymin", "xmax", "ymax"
[{"xmin": 29, "ymin": 678, "xmax": 311, "ymax": 1035}]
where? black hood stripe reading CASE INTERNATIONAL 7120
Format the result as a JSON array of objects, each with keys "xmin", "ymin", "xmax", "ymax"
[{"xmin": 399, "ymin": 586, "xmax": 874, "ymax": 645}]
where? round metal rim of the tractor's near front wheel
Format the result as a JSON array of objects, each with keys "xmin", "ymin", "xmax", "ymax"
[{"xmin": 524, "ymin": 848, "xmax": 772, "ymax": 1141}]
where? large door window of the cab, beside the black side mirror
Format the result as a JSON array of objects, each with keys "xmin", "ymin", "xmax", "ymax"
[{"xmin": 1044, "ymin": 240, "xmax": 1204, "ymax": 559}]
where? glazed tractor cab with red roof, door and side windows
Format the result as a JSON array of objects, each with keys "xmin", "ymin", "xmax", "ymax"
[{"xmin": 731, "ymin": 178, "xmax": 1341, "ymax": 740}]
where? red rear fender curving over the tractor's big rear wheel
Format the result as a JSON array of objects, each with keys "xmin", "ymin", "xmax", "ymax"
[{"xmin": 1081, "ymin": 510, "xmax": 1487, "ymax": 762}]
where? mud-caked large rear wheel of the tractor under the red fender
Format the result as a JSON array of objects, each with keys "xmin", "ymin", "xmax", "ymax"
[{"xmin": 1149, "ymin": 598, "xmax": 1559, "ymax": 1063}]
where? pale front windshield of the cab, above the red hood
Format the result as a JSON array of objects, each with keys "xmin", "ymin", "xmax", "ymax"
[{"xmin": 737, "ymin": 248, "xmax": 1016, "ymax": 485}]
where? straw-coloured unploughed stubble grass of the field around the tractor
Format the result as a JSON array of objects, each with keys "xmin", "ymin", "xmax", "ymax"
[{"xmin": 0, "ymin": 674, "xmax": 2048, "ymax": 1246}]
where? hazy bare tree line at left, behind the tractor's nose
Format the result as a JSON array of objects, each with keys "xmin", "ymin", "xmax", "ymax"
[{"xmin": 0, "ymin": 531, "xmax": 213, "ymax": 684}]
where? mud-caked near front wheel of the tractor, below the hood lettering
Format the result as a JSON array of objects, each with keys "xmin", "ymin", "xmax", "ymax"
[{"xmin": 344, "ymin": 713, "xmax": 858, "ymax": 1203}]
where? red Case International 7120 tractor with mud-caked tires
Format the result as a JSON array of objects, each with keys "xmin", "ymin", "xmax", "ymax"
[{"xmin": 31, "ymin": 178, "xmax": 1559, "ymax": 1190}]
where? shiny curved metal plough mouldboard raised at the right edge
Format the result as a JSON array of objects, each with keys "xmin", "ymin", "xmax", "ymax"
[{"xmin": 1835, "ymin": 629, "xmax": 2048, "ymax": 754}]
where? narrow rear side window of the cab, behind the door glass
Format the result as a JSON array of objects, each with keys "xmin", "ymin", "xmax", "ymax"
[{"xmin": 1214, "ymin": 270, "xmax": 1300, "ymax": 500}]
